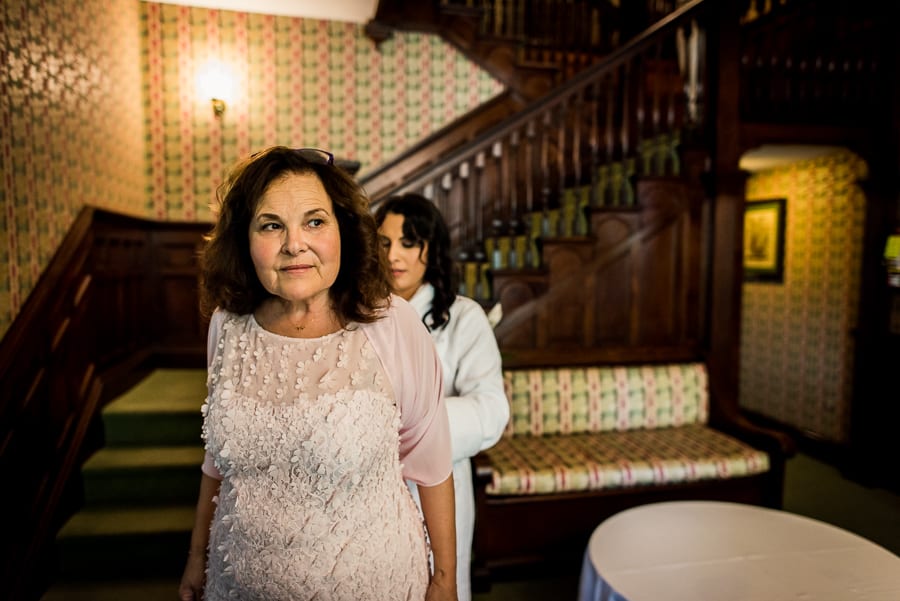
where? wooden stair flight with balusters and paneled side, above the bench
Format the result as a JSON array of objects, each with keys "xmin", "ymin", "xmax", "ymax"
[{"xmin": 364, "ymin": 1, "xmax": 710, "ymax": 365}]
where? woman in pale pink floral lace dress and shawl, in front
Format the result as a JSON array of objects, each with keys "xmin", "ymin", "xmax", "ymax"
[{"xmin": 179, "ymin": 147, "xmax": 456, "ymax": 601}]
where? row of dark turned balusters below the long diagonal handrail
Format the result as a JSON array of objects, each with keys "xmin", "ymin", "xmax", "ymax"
[{"xmin": 394, "ymin": 11, "xmax": 702, "ymax": 286}]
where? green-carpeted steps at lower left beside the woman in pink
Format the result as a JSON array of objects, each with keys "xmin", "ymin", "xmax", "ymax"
[{"xmin": 56, "ymin": 369, "xmax": 206, "ymax": 584}]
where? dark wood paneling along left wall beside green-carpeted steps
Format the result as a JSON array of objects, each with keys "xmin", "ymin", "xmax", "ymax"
[{"xmin": 0, "ymin": 207, "xmax": 209, "ymax": 599}]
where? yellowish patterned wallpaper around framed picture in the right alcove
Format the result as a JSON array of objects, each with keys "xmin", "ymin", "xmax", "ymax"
[{"xmin": 740, "ymin": 152, "xmax": 868, "ymax": 442}]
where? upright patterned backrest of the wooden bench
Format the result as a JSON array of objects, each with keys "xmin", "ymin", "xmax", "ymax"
[{"xmin": 503, "ymin": 363, "xmax": 709, "ymax": 436}]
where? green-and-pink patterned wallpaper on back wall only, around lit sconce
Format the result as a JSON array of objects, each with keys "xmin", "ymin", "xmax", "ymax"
[{"xmin": 141, "ymin": 3, "xmax": 502, "ymax": 221}]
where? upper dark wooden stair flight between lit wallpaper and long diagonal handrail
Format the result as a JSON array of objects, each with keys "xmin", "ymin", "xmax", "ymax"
[{"xmin": 363, "ymin": 0, "xmax": 676, "ymax": 198}]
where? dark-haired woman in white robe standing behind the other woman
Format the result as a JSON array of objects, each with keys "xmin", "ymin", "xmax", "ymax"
[{"xmin": 375, "ymin": 194, "xmax": 509, "ymax": 601}]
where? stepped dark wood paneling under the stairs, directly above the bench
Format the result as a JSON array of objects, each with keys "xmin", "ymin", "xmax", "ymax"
[{"xmin": 495, "ymin": 178, "xmax": 708, "ymax": 365}]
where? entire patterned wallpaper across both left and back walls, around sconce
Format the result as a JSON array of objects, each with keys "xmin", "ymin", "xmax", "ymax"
[{"xmin": 0, "ymin": 0, "xmax": 502, "ymax": 337}]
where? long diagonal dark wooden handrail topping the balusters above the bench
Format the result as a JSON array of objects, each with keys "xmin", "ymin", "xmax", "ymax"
[{"xmin": 373, "ymin": 0, "xmax": 712, "ymax": 206}]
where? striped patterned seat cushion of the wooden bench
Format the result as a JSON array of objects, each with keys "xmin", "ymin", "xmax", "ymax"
[{"xmin": 482, "ymin": 424, "xmax": 769, "ymax": 495}]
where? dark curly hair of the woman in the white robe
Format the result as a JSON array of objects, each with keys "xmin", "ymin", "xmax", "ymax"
[{"xmin": 375, "ymin": 193, "xmax": 459, "ymax": 330}]
